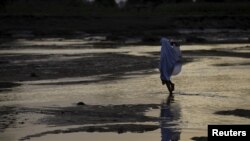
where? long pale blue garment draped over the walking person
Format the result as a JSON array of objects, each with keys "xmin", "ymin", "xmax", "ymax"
[{"xmin": 160, "ymin": 38, "xmax": 182, "ymax": 81}]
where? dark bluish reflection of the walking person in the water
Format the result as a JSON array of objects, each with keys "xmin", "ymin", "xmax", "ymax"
[{"xmin": 160, "ymin": 95, "xmax": 180, "ymax": 141}]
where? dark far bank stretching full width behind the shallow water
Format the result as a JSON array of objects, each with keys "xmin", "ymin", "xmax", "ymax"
[{"xmin": 0, "ymin": 16, "xmax": 250, "ymax": 44}]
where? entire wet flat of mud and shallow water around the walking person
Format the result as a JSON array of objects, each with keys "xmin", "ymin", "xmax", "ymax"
[{"xmin": 0, "ymin": 38, "xmax": 250, "ymax": 141}]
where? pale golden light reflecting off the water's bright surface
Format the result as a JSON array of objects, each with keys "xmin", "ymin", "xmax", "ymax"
[{"xmin": 0, "ymin": 39, "xmax": 250, "ymax": 141}]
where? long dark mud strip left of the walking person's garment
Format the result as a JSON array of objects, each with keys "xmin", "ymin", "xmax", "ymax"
[{"xmin": 0, "ymin": 53, "xmax": 158, "ymax": 81}]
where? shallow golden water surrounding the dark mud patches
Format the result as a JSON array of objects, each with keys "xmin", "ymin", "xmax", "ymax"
[{"xmin": 0, "ymin": 40, "xmax": 250, "ymax": 141}]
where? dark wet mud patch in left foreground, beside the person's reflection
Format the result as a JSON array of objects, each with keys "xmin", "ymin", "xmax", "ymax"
[{"xmin": 0, "ymin": 102, "xmax": 164, "ymax": 140}]
